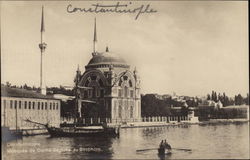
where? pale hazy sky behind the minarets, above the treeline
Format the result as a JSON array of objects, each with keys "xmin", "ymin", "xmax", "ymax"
[{"xmin": 0, "ymin": 1, "xmax": 249, "ymax": 96}]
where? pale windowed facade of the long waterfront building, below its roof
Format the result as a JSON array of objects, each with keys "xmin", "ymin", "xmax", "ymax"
[{"xmin": 1, "ymin": 97, "xmax": 60, "ymax": 130}]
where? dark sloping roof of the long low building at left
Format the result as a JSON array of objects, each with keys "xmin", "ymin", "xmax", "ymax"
[{"xmin": 1, "ymin": 86, "xmax": 58, "ymax": 100}]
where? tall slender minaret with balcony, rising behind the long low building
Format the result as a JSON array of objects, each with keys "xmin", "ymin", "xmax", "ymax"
[{"xmin": 39, "ymin": 7, "xmax": 47, "ymax": 95}]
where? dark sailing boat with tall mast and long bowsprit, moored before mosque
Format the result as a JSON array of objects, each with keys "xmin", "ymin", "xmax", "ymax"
[{"xmin": 25, "ymin": 67, "xmax": 120, "ymax": 137}]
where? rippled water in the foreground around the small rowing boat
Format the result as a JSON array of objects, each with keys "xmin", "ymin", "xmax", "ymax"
[{"xmin": 2, "ymin": 123, "xmax": 249, "ymax": 160}]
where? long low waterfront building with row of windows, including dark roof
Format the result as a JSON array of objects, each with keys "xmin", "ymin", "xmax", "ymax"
[{"xmin": 1, "ymin": 86, "xmax": 61, "ymax": 130}]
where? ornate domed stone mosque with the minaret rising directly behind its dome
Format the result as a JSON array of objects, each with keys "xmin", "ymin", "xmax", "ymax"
[{"xmin": 77, "ymin": 20, "xmax": 141, "ymax": 123}]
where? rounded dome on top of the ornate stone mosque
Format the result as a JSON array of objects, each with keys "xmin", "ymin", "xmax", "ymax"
[{"xmin": 88, "ymin": 51, "xmax": 126, "ymax": 65}]
